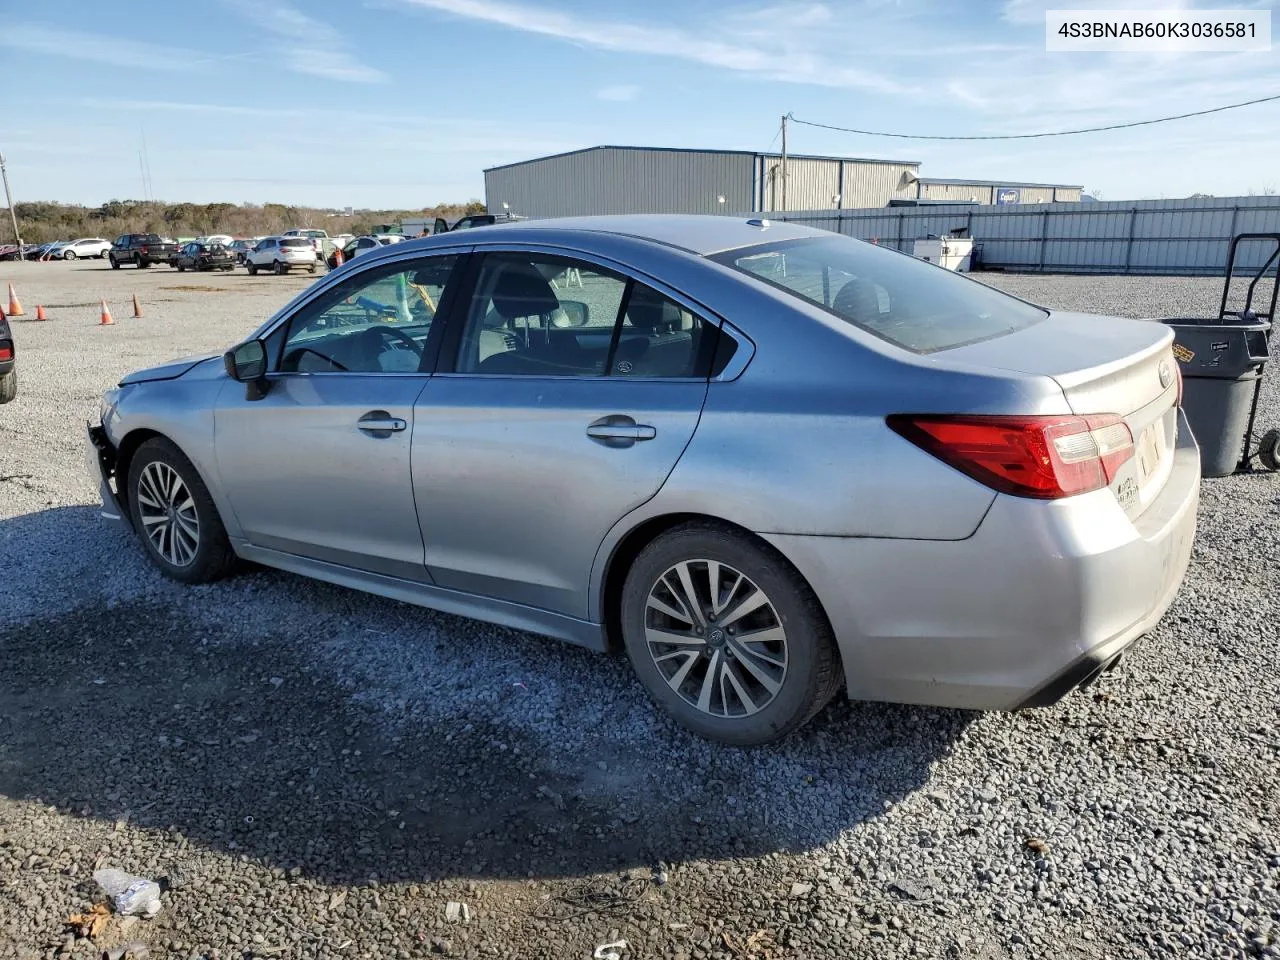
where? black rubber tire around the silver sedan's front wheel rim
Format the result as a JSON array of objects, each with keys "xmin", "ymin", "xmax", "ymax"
[{"xmin": 127, "ymin": 436, "xmax": 236, "ymax": 584}]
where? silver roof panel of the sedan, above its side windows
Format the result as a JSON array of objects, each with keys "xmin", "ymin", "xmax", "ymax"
[{"xmin": 440, "ymin": 214, "xmax": 832, "ymax": 256}]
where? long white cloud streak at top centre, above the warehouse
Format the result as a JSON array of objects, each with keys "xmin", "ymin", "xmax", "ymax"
[{"xmin": 398, "ymin": 0, "xmax": 908, "ymax": 93}]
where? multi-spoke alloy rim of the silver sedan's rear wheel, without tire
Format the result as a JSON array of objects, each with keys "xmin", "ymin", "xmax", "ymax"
[{"xmin": 644, "ymin": 559, "xmax": 788, "ymax": 718}]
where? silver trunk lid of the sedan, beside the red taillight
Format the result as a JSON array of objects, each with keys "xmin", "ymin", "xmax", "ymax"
[{"xmin": 940, "ymin": 311, "xmax": 1179, "ymax": 518}]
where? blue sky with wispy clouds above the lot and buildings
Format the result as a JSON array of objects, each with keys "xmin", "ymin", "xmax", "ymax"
[{"xmin": 0, "ymin": 0, "xmax": 1280, "ymax": 209}]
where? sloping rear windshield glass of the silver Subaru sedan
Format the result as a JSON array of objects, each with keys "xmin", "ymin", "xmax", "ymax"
[{"xmin": 712, "ymin": 234, "xmax": 1048, "ymax": 353}]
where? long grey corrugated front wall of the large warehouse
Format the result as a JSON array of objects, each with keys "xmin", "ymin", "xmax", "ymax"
[{"xmin": 484, "ymin": 148, "xmax": 752, "ymax": 218}]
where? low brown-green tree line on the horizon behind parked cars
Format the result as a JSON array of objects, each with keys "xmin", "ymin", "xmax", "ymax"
[{"xmin": 0, "ymin": 200, "xmax": 485, "ymax": 243}]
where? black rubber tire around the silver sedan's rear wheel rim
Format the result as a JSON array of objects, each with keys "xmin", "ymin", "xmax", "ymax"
[{"xmin": 621, "ymin": 522, "xmax": 844, "ymax": 746}]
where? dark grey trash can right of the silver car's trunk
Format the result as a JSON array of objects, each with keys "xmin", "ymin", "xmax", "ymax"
[{"xmin": 1162, "ymin": 316, "xmax": 1271, "ymax": 476}]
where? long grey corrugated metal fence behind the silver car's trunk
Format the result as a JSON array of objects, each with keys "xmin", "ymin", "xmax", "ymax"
[{"xmin": 747, "ymin": 196, "xmax": 1280, "ymax": 274}]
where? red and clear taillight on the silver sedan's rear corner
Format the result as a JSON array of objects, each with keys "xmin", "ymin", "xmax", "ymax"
[{"xmin": 888, "ymin": 413, "xmax": 1133, "ymax": 500}]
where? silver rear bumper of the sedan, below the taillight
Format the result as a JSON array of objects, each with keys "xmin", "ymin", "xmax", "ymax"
[{"xmin": 767, "ymin": 412, "xmax": 1201, "ymax": 709}]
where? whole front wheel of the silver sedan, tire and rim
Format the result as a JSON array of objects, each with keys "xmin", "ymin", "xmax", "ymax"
[{"xmin": 128, "ymin": 436, "xmax": 236, "ymax": 584}]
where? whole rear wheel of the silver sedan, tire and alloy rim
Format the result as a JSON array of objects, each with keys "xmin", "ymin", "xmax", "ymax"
[{"xmin": 622, "ymin": 522, "xmax": 841, "ymax": 746}]
